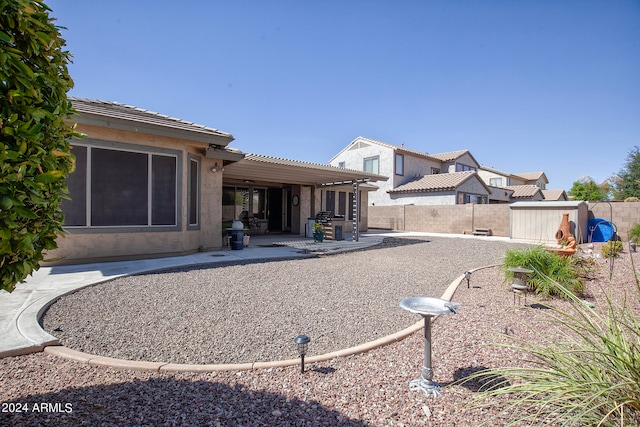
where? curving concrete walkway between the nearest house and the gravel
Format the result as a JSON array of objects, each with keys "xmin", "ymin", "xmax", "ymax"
[{"xmin": 0, "ymin": 233, "xmax": 384, "ymax": 358}]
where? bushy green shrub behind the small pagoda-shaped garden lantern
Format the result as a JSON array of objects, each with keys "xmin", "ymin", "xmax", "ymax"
[{"xmin": 502, "ymin": 246, "xmax": 584, "ymax": 297}]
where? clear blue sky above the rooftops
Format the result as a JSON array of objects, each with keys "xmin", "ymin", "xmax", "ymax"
[{"xmin": 46, "ymin": 0, "xmax": 640, "ymax": 190}]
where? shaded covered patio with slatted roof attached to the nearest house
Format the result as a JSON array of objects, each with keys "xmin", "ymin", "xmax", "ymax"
[{"xmin": 222, "ymin": 154, "xmax": 387, "ymax": 240}]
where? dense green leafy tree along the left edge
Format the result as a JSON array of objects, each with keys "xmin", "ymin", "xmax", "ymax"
[{"xmin": 0, "ymin": 0, "xmax": 79, "ymax": 292}]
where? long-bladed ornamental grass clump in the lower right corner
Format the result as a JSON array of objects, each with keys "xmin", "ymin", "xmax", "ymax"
[{"xmin": 465, "ymin": 276, "xmax": 640, "ymax": 427}]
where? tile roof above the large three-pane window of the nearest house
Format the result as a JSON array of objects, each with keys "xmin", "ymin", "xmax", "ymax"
[{"xmin": 69, "ymin": 97, "xmax": 233, "ymax": 141}]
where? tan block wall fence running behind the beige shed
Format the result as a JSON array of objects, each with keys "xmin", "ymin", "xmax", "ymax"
[{"xmin": 368, "ymin": 202, "xmax": 640, "ymax": 241}]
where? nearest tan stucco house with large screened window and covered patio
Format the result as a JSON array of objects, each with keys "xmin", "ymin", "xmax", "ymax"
[{"xmin": 47, "ymin": 98, "xmax": 386, "ymax": 263}]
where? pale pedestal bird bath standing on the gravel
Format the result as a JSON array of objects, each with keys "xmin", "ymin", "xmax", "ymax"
[{"xmin": 400, "ymin": 297, "xmax": 460, "ymax": 397}]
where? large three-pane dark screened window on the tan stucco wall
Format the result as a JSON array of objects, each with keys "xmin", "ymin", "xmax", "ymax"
[{"xmin": 62, "ymin": 146, "xmax": 178, "ymax": 227}]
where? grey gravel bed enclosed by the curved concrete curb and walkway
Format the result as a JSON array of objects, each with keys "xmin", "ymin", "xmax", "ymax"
[{"xmin": 42, "ymin": 238, "xmax": 528, "ymax": 364}]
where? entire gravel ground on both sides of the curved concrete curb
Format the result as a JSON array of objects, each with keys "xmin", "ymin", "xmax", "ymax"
[{"xmin": 0, "ymin": 238, "xmax": 640, "ymax": 426}]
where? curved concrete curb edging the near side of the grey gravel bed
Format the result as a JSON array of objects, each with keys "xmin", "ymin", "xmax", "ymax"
[{"xmin": 43, "ymin": 265, "xmax": 495, "ymax": 373}]
